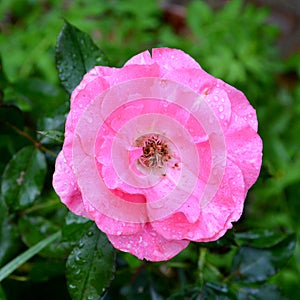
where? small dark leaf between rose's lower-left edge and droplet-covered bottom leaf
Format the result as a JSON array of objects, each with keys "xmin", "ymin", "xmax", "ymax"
[{"xmin": 62, "ymin": 212, "xmax": 91, "ymax": 242}]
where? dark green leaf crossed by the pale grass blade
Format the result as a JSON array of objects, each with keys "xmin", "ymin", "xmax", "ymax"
[{"xmin": 19, "ymin": 215, "xmax": 71, "ymax": 258}]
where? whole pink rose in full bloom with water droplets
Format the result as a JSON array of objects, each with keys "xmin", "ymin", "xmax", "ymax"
[{"xmin": 53, "ymin": 48, "xmax": 262, "ymax": 261}]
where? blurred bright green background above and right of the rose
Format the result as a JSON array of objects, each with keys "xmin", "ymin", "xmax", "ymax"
[{"xmin": 0, "ymin": 0, "xmax": 300, "ymax": 299}]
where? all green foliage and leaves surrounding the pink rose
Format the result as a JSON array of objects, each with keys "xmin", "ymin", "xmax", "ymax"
[{"xmin": 0, "ymin": 0, "xmax": 300, "ymax": 300}]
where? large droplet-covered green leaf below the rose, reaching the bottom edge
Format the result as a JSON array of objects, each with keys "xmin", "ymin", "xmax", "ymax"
[{"xmin": 66, "ymin": 224, "xmax": 115, "ymax": 300}]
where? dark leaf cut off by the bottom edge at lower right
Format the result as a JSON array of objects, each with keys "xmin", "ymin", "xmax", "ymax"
[{"xmin": 238, "ymin": 285, "xmax": 287, "ymax": 300}]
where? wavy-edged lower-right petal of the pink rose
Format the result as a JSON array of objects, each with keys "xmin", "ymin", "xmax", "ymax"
[{"xmin": 152, "ymin": 161, "xmax": 245, "ymax": 242}]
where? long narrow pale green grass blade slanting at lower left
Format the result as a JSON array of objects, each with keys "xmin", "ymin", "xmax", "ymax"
[{"xmin": 0, "ymin": 231, "xmax": 61, "ymax": 281}]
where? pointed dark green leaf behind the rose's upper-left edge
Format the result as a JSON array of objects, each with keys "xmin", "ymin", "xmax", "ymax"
[{"xmin": 56, "ymin": 21, "xmax": 107, "ymax": 94}]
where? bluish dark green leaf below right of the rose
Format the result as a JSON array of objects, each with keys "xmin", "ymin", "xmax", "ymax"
[{"xmin": 232, "ymin": 234, "xmax": 296, "ymax": 283}]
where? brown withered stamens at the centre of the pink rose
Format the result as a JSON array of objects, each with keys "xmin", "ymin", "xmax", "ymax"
[{"xmin": 136, "ymin": 134, "xmax": 172, "ymax": 169}]
